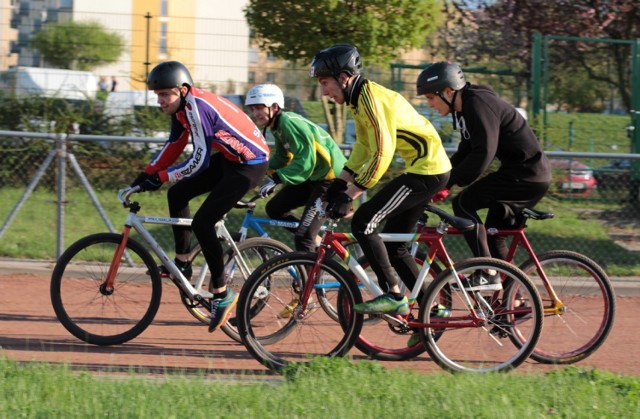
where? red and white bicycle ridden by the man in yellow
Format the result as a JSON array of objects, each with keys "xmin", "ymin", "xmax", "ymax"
[{"xmin": 236, "ymin": 206, "xmax": 543, "ymax": 372}]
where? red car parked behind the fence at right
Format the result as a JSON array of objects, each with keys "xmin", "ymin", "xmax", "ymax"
[{"xmin": 550, "ymin": 159, "xmax": 597, "ymax": 196}]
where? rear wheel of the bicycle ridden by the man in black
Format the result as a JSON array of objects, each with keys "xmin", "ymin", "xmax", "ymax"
[{"xmin": 514, "ymin": 250, "xmax": 616, "ymax": 364}]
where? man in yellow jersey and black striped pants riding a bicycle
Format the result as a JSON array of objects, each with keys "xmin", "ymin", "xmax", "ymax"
[{"xmin": 311, "ymin": 44, "xmax": 451, "ymax": 315}]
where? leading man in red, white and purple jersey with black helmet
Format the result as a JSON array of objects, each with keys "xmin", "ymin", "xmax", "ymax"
[{"xmin": 132, "ymin": 61, "xmax": 269, "ymax": 332}]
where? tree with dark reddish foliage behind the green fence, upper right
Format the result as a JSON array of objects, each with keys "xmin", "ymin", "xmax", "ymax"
[{"xmin": 441, "ymin": 0, "xmax": 640, "ymax": 110}]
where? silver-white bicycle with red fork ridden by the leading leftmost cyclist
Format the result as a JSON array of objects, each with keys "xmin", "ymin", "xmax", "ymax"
[{"xmin": 50, "ymin": 187, "xmax": 291, "ymax": 346}]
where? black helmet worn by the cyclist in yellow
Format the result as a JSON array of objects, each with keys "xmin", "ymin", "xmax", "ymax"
[{"xmin": 309, "ymin": 44, "xmax": 362, "ymax": 77}]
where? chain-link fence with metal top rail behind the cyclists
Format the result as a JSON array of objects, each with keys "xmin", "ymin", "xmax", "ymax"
[{"xmin": 0, "ymin": 131, "xmax": 640, "ymax": 276}]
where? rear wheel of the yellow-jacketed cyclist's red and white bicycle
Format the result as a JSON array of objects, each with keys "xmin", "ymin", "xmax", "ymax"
[{"xmin": 417, "ymin": 258, "xmax": 544, "ymax": 372}]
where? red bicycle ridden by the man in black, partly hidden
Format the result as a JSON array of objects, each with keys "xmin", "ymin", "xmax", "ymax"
[{"xmin": 356, "ymin": 209, "xmax": 616, "ymax": 364}]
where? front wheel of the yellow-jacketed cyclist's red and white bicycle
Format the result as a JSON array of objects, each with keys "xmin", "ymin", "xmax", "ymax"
[{"xmin": 236, "ymin": 252, "xmax": 362, "ymax": 372}]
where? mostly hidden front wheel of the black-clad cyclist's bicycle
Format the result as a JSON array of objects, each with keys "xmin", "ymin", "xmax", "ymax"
[{"xmin": 355, "ymin": 259, "xmax": 450, "ymax": 361}]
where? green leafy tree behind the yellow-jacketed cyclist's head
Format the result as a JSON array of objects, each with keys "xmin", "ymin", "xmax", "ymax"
[{"xmin": 244, "ymin": 0, "xmax": 440, "ymax": 141}]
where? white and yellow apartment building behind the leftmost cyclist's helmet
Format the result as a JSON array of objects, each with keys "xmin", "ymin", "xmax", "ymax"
[{"xmin": 7, "ymin": 0, "xmax": 249, "ymax": 94}]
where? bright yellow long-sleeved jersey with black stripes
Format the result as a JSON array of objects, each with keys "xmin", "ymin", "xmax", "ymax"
[{"xmin": 345, "ymin": 78, "xmax": 451, "ymax": 189}]
